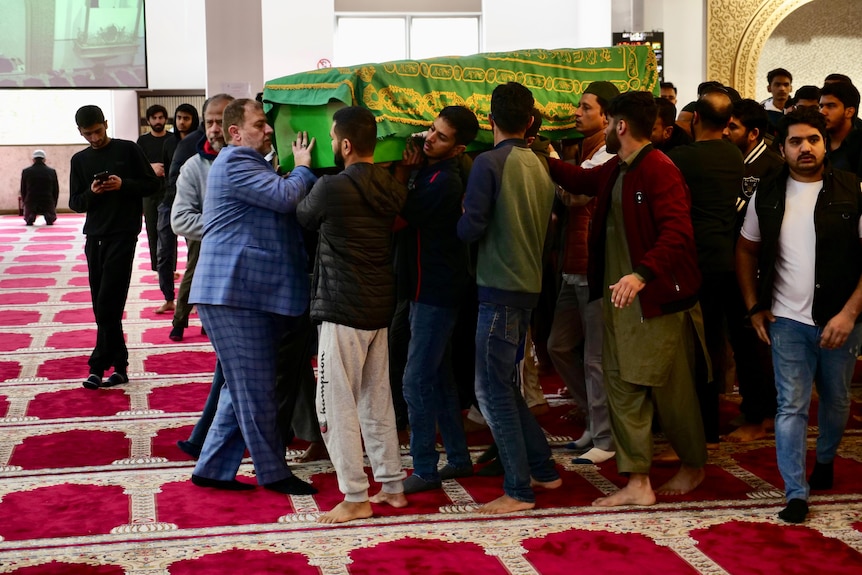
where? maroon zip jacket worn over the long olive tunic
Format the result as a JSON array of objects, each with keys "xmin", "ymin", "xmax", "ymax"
[{"xmin": 548, "ymin": 145, "xmax": 701, "ymax": 318}]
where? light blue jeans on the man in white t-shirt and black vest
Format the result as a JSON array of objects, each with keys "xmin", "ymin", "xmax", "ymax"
[{"xmin": 769, "ymin": 317, "xmax": 862, "ymax": 501}]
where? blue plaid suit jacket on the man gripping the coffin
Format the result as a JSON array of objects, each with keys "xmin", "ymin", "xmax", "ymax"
[{"xmin": 189, "ymin": 146, "xmax": 317, "ymax": 316}]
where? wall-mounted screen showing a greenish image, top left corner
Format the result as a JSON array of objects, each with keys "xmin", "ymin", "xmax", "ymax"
[{"xmin": 0, "ymin": 0, "xmax": 147, "ymax": 89}]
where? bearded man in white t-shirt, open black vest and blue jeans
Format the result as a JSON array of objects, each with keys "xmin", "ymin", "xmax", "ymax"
[{"xmin": 736, "ymin": 109, "xmax": 862, "ymax": 523}]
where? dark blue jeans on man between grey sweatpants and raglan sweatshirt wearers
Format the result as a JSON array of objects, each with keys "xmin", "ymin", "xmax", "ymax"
[{"xmin": 403, "ymin": 302, "xmax": 472, "ymax": 481}]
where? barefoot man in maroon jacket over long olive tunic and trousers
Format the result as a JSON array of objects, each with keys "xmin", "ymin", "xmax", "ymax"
[{"xmin": 549, "ymin": 92, "xmax": 706, "ymax": 507}]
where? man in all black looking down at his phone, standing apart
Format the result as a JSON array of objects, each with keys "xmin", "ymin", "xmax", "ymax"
[{"xmin": 69, "ymin": 105, "xmax": 161, "ymax": 389}]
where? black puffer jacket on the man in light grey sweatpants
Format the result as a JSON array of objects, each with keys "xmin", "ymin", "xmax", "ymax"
[{"xmin": 296, "ymin": 163, "xmax": 407, "ymax": 330}]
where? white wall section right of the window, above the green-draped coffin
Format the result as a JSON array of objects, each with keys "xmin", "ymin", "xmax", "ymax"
[{"xmin": 482, "ymin": 0, "xmax": 611, "ymax": 52}]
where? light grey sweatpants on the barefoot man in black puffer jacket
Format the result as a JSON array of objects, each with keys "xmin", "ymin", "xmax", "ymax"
[{"xmin": 315, "ymin": 322, "xmax": 405, "ymax": 502}]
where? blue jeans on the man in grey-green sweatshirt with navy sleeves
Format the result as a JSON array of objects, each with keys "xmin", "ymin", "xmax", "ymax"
[{"xmin": 476, "ymin": 302, "xmax": 560, "ymax": 503}]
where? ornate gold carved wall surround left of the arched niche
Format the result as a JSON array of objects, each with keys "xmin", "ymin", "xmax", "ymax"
[{"xmin": 706, "ymin": 0, "xmax": 812, "ymax": 98}]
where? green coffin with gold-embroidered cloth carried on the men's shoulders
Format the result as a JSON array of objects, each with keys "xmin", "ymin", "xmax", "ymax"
[{"xmin": 263, "ymin": 46, "xmax": 659, "ymax": 170}]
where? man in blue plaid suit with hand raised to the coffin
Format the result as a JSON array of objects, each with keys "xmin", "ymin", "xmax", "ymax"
[{"xmin": 189, "ymin": 99, "xmax": 317, "ymax": 495}]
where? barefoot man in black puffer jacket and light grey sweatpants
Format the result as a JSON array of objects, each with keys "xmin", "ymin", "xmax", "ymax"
[{"xmin": 296, "ymin": 106, "xmax": 407, "ymax": 523}]
